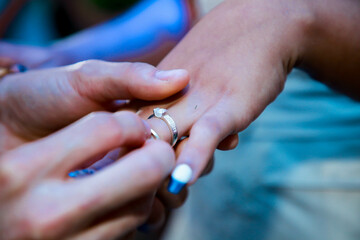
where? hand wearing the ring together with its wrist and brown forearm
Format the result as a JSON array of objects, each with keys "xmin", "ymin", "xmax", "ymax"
[{"xmin": 140, "ymin": 0, "xmax": 360, "ymax": 184}]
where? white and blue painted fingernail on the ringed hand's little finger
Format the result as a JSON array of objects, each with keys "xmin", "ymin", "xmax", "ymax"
[{"xmin": 167, "ymin": 164, "xmax": 193, "ymax": 194}]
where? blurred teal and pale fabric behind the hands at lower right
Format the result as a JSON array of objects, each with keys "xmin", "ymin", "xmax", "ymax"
[{"xmin": 164, "ymin": 70, "xmax": 360, "ymax": 240}]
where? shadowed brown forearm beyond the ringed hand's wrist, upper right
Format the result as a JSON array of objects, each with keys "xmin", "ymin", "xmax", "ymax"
[{"xmin": 299, "ymin": 0, "xmax": 360, "ymax": 99}]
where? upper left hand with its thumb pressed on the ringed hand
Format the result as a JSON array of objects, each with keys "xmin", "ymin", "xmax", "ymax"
[{"xmin": 0, "ymin": 60, "xmax": 189, "ymax": 149}]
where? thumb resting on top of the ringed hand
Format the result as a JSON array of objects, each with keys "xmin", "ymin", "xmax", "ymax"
[{"xmin": 65, "ymin": 60, "xmax": 189, "ymax": 102}]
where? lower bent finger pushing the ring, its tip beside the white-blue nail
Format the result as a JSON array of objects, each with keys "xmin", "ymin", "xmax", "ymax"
[{"xmin": 14, "ymin": 140, "xmax": 175, "ymax": 239}]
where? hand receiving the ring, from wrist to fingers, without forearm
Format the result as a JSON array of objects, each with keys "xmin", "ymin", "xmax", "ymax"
[{"xmin": 140, "ymin": 1, "xmax": 312, "ymax": 184}]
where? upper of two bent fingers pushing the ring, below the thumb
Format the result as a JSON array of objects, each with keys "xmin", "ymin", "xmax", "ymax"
[{"xmin": 1, "ymin": 112, "xmax": 150, "ymax": 187}]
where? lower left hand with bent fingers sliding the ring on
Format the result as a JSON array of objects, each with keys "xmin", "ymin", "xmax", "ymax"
[{"xmin": 0, "ymin": 112, "xmax": 175, "ymax": 240}]
